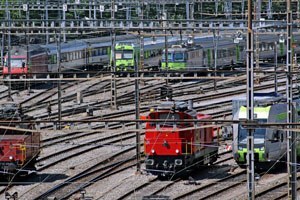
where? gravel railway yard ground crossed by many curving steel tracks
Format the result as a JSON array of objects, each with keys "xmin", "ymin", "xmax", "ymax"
[{"xmin": 0, "ymin": 67, "xmax": 298, "ymax": 199}]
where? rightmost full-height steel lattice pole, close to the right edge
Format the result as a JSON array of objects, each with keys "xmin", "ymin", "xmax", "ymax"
[{"xmin": 286, "ymin": 0, "xmax": 297, "ymax": 197}]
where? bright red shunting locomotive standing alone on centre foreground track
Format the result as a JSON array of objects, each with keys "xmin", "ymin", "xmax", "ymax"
[{"xmin": 144, "ymin": 102, "xmax": 218, "ymax": 176}]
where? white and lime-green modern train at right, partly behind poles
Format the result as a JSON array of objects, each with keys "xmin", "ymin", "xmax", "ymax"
[{"xmin": 232, "ymin": 93, "xmax": 300, "ymax": 170}]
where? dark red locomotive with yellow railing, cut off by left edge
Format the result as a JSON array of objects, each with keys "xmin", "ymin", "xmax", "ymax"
[{"xmin": 0, "ymin": 103, "xmax": 40, "ymax": 179}]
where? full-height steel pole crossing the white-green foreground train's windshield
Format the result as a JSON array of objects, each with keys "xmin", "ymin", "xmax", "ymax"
[{"xmin": 247, "ymin": 0, "xmax": 255, "ymax": 200}]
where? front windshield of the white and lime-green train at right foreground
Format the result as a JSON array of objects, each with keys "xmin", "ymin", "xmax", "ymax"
[{"xmin": 238, "ymin": 119, "xmax": 267, "ymax": 144}]
